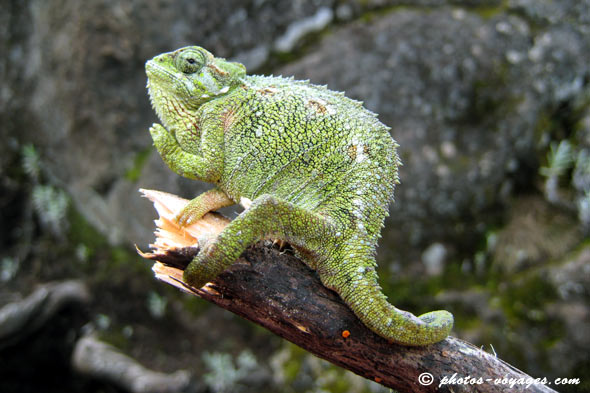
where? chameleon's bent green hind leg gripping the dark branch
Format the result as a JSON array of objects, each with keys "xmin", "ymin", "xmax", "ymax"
[{"xmin": 184, "ymin": 195, "xmax": 335, "ymax": 288}]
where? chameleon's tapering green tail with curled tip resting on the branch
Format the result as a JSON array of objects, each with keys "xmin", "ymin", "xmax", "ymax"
[{"xmin": 318, "ymin": 242, "xmax": 453, "ymax": 345}]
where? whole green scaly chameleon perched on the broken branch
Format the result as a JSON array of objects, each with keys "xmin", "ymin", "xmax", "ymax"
[{"xmin": 145, "ymin": 46, "xmax": 453, "ymax": 346}]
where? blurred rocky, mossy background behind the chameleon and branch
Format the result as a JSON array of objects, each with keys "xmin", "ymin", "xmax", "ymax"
[{"xmin": 0, "ymin": 0, "xmax": 590, "ymax": 392}]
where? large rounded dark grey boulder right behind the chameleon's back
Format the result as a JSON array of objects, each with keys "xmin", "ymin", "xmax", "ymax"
[{"xmin": 280, "ymin": 7, "xmax": 590, "ymax": 258}]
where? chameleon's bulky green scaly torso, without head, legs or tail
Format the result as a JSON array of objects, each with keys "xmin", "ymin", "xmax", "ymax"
[{"xmin": 220, "ymin": 76, "xmax": 399, "ymax": 241}]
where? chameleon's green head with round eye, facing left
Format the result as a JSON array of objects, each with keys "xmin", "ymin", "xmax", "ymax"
[{"xmin": 145, "ymin": 46, "xmax": 246, "ymax": 127}]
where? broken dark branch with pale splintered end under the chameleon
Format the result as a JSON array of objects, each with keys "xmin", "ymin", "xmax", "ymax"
[{"xmin": 140, "ymin": 190, "xmax": 553, "ymax": 392}]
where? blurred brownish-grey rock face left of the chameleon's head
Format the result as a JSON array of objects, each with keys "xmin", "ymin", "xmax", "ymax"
[{"xmin": 0, "ymin": 0, "xmax": 333, "ymax": 244}]
